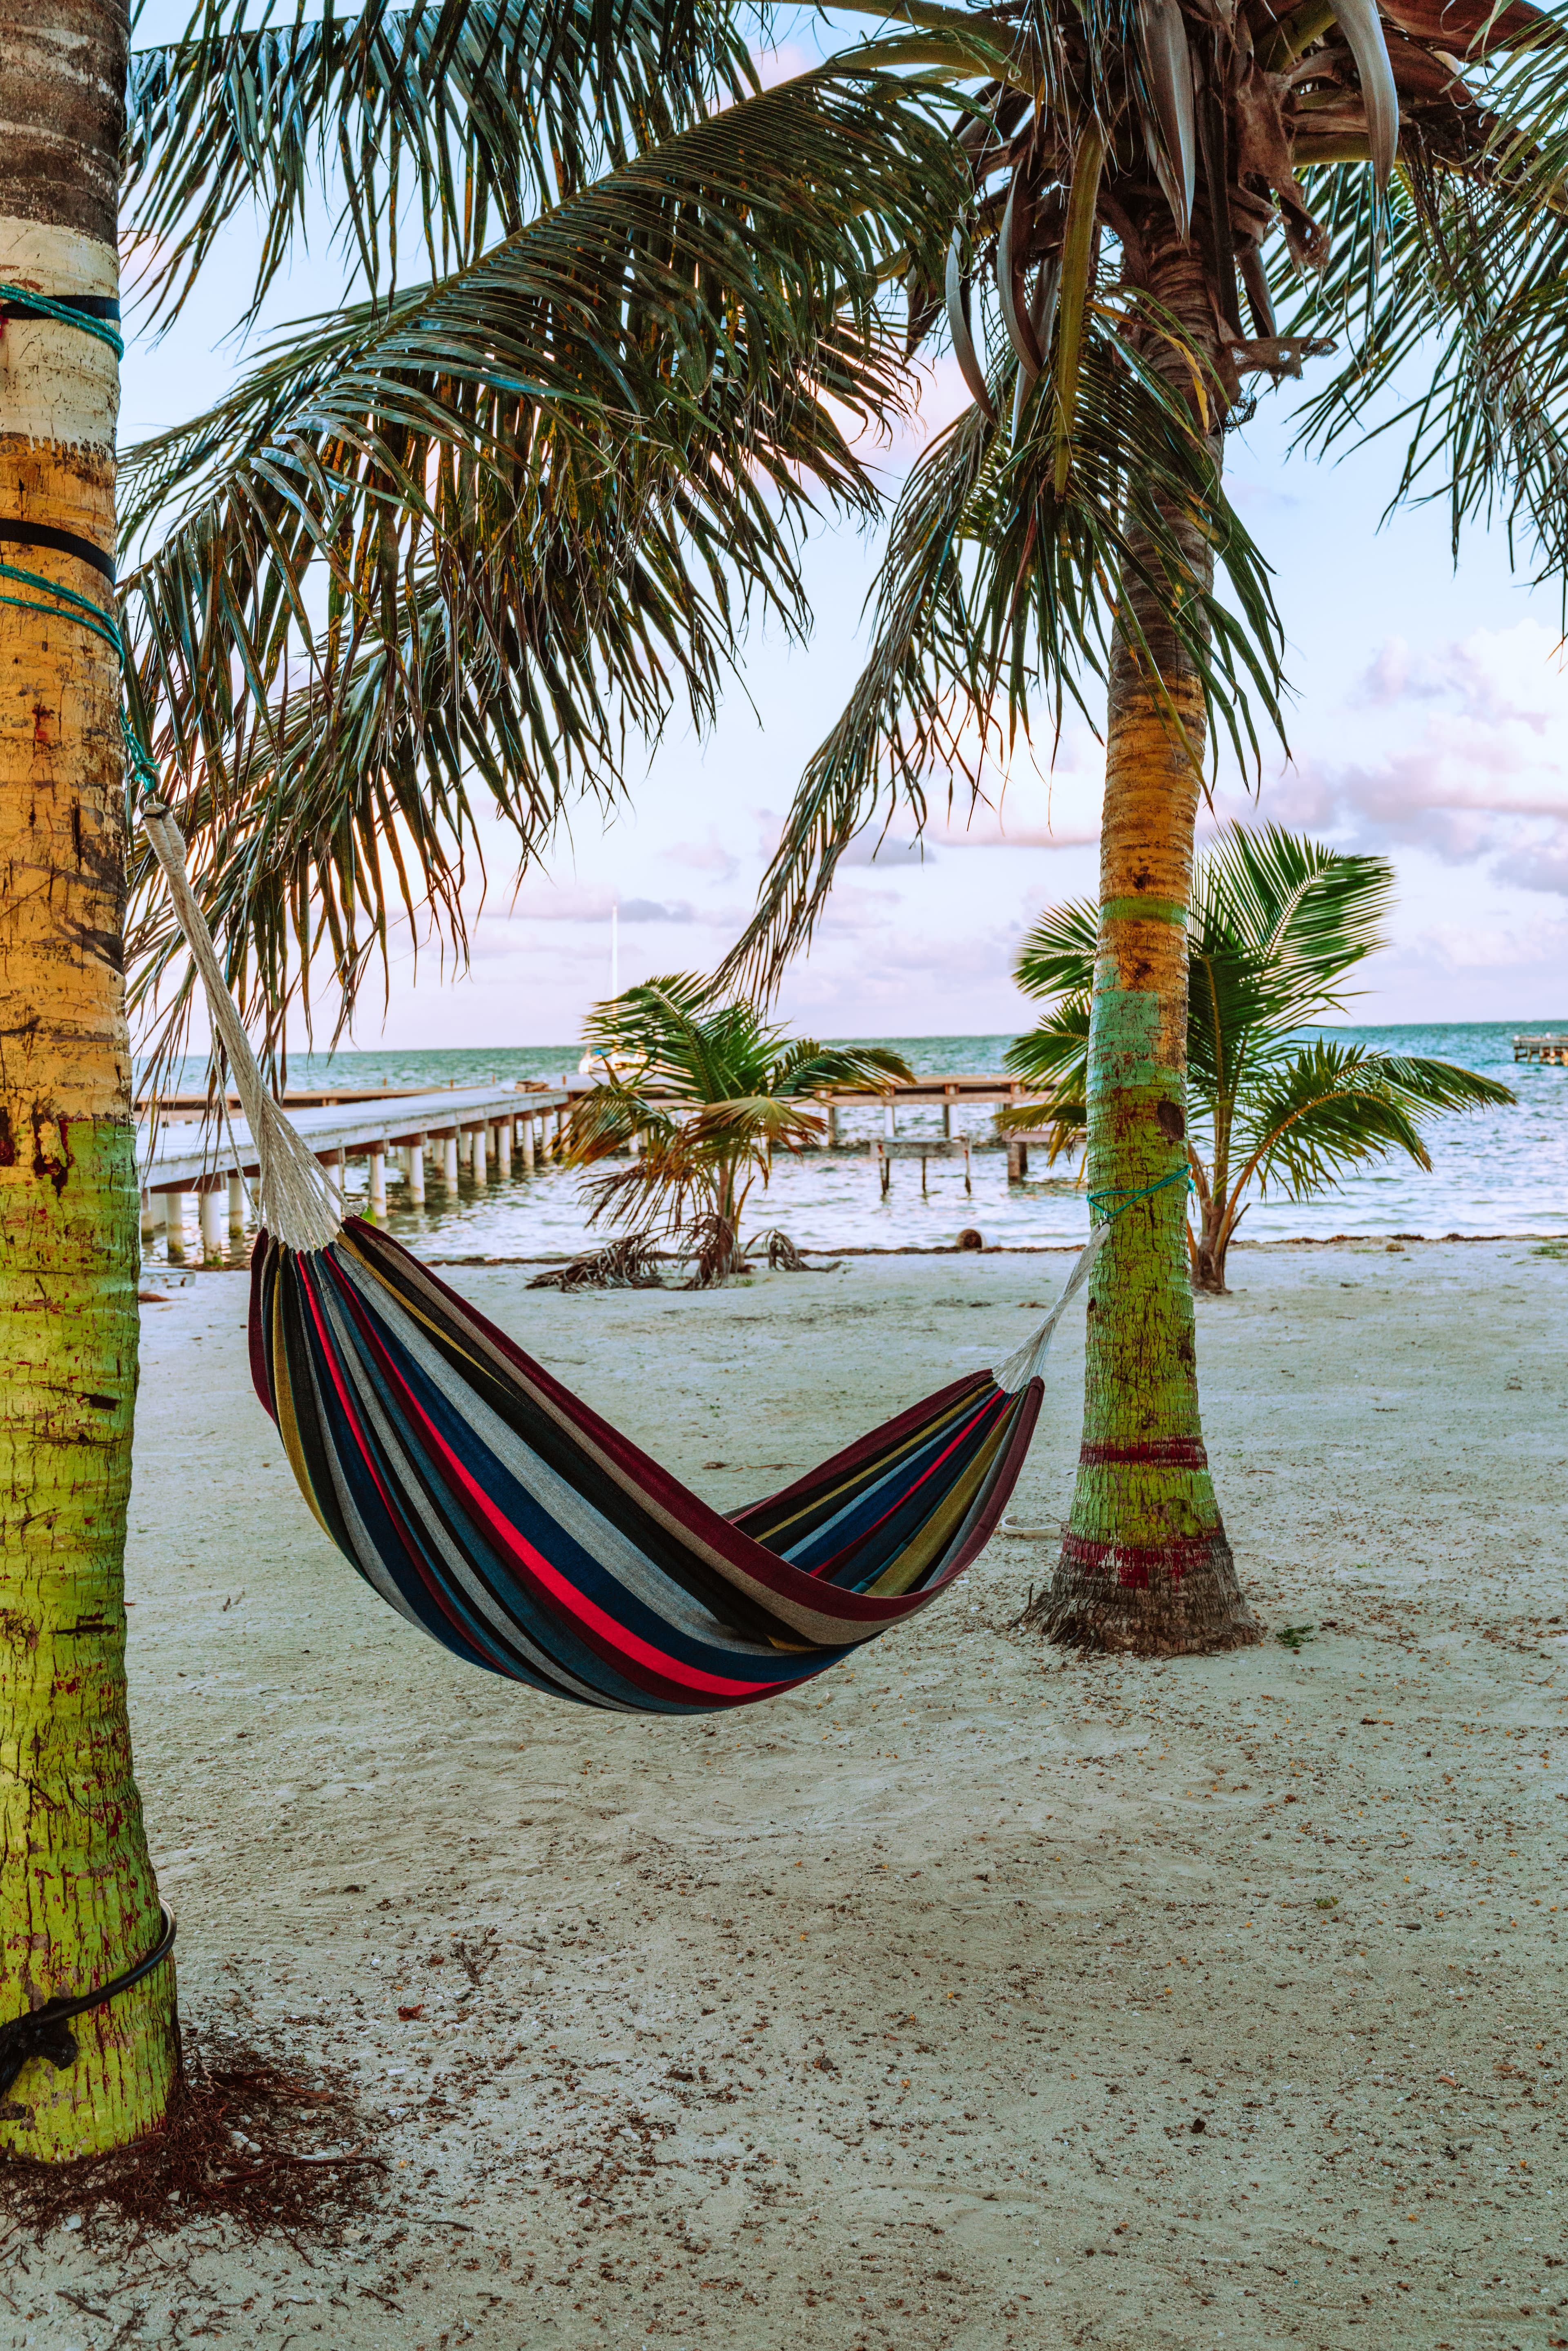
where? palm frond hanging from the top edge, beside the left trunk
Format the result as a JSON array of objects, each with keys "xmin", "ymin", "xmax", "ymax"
[{"xmin": 122, "ymin": 0, "xmax": 755, "ymax": 324}]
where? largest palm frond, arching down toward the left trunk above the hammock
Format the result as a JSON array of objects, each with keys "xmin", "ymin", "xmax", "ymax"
[{"xmin": 122, "ymin": 71, "xmax": 954, "ymax": 1058}]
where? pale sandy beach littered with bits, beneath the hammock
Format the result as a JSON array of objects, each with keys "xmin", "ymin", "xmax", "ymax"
[{"xmin": 27, "ymin": 1241, "xmax": 1568, "ymax": 2351}]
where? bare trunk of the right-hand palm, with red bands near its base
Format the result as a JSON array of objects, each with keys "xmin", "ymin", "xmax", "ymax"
[{"xmin": 1025, "ymin": 247, "xmax": 1260, "ymax": 1655}]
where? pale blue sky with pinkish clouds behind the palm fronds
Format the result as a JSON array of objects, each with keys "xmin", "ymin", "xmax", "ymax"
[{"xmin": 122, "ymin": 9, "xmax": 1568, "ymax": 1049}]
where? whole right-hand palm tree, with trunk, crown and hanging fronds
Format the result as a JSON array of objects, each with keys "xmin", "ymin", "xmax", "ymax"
[{"xmin": 724, "ymin": 0, "xmax": 1568, "ymax": 1653}]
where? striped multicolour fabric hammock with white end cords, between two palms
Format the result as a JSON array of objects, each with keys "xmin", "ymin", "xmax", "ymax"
[{"xmin": 143, "ymin": 804, "xmax": 1107, "ymax": 1714}]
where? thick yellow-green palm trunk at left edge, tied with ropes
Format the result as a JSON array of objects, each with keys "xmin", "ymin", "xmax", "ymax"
[{"xmin": 0, "ymin": 0, "xmax": 176, "ymax": 2161}]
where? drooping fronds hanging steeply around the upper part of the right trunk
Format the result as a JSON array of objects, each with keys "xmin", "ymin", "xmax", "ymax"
[{"xmin": 722, "ymin": 303, "xmax": 1283, "ymax": 987}]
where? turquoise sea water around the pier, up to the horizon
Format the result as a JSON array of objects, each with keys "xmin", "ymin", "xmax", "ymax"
[{"xmin": 147, "ymin": 1018, "xmax": 1568, "ymax": 1258}]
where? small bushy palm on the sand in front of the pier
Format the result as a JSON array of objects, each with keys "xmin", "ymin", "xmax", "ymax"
[{"xmin": 566, "ymin": 973, "xmax": 912, "ymax": 1288}]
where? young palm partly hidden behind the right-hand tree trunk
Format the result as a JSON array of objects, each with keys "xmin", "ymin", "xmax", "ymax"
[{"xmin": 1002, "ymin": 825, "xmax": 1514, "ymax": 1291}]
